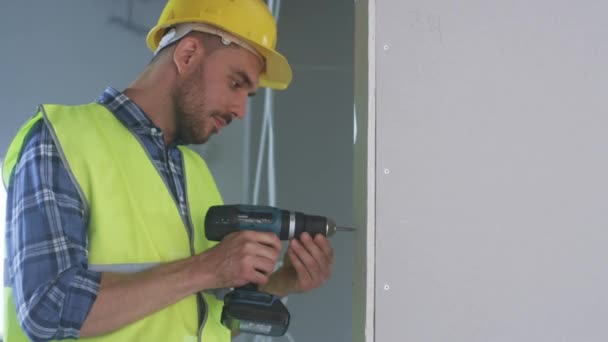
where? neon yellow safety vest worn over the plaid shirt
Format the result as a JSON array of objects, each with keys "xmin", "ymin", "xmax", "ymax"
[{"xmin": 2, "ymin": 103, "xmax": 230, "ymax": 342}]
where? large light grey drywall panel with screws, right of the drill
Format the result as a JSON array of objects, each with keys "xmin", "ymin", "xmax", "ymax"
[{"xmin": 374, "ymin": 0, "xmax": 608, "ymax": 342}]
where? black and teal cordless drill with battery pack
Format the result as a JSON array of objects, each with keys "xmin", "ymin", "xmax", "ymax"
[{"xmin": 205, "ymin": 205, "xmax": 353, "ymax": 336}]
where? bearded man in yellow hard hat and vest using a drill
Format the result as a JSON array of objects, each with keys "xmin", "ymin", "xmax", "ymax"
[{"xmin": 3, "ymin": 0, "xmax": 334, "ymax": 342}]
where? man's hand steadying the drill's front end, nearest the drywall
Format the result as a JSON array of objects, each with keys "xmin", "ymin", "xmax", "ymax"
[{"xmin": 261, "ymin": 233, "xmax": 334, "ymax": 296}]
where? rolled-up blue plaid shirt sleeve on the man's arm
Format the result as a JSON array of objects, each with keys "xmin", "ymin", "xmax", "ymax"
[{"xmin": 5, "ymin": 122, "xmax": 101, "ymax": 341}]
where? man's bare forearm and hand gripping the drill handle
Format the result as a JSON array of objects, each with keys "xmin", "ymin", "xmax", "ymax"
[{"xmin": 80, "ymin": 231, "xmax": 282, "ymax": 337}]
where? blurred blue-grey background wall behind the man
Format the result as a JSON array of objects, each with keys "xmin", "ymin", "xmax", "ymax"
[{"xmin": 0, "ymin": 0, "xmax": 354, "ymax": 341}]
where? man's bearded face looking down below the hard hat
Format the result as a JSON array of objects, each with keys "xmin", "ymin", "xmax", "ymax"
[{"xmin": 174, "ymin": 42, "xmax": 262, "ymax": 144}]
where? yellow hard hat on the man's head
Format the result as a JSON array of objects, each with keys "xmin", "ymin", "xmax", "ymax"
[{"xmin": 147, "ymin": 0, "xmax": 292, "ymax": 89}]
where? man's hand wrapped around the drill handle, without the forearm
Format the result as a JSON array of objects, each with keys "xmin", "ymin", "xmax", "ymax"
[{"xmin": 193, "ymin": 231, "xmax": 282, "ymax": 289}]
